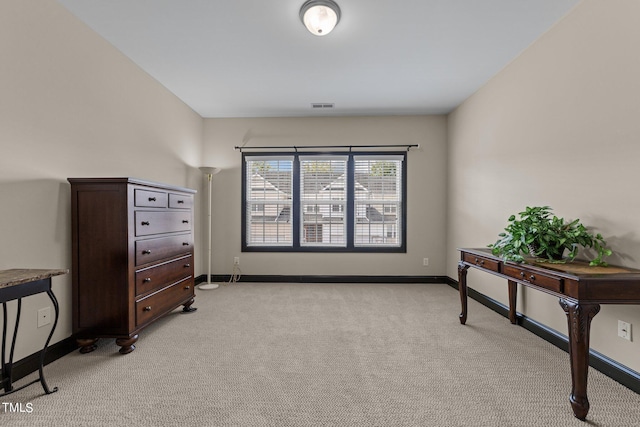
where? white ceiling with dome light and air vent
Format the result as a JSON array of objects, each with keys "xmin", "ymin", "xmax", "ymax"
[{"xmin": 58, "ymin": 0, "xmax": 580, "ymax": 117}]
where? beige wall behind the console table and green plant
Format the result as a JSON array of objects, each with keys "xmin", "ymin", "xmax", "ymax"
[{"xmin": 447, "ymin": 0, "xmax": 640, "ymax": 371}]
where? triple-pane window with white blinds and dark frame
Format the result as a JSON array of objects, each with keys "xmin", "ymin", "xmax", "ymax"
[{"xmin": 242, "ymin": 153, "xmax": 406, "ymax": 252}]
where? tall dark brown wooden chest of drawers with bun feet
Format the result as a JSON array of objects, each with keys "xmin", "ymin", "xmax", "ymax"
[{"xmin": 68, "ymin": 178, "xmax": 195, "ymax": 354}]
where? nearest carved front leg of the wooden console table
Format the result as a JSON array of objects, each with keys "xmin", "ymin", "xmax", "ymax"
[{"xmin": 559, "ymin": 298, "xmax": 600, "ymax": 421}]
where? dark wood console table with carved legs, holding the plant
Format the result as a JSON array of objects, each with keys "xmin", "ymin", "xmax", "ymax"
[{"xmin": 458, "ymin": 249, "xmax": 640, "ymax": 421}]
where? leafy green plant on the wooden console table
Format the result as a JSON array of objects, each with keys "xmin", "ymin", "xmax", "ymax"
[{"xmin": 489, "ymin": 206, "xmax": 612, "ymax": 266}]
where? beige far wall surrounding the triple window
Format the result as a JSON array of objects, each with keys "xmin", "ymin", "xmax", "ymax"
[{"xmin": 203, "ymin": 116, "xmax": 446, "ymax": 276}]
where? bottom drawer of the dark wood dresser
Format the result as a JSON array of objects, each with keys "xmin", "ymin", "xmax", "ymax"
[{"xmin": 136, "ymin": 278, "xmax": 194, "ymax": 326}]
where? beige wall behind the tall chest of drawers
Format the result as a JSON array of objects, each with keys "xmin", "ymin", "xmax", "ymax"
[{"xmin": 0, "ymin": 0, "xmax": 203, "ymax": 360}]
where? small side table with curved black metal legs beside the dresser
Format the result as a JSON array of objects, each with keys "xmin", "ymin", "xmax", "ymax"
[{"xmin": 0, "ymin": 269, "xmax": 69, "ymax": 396}]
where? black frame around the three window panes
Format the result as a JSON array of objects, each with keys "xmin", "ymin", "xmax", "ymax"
[{"xmin": 241, "ymin": 151, "xmax": 408, "ymax": 253}]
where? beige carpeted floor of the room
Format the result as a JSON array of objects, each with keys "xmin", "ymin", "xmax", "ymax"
[{"xmin": 0, "ymin": 283, "xmax": 640, "ymax": 427}]
